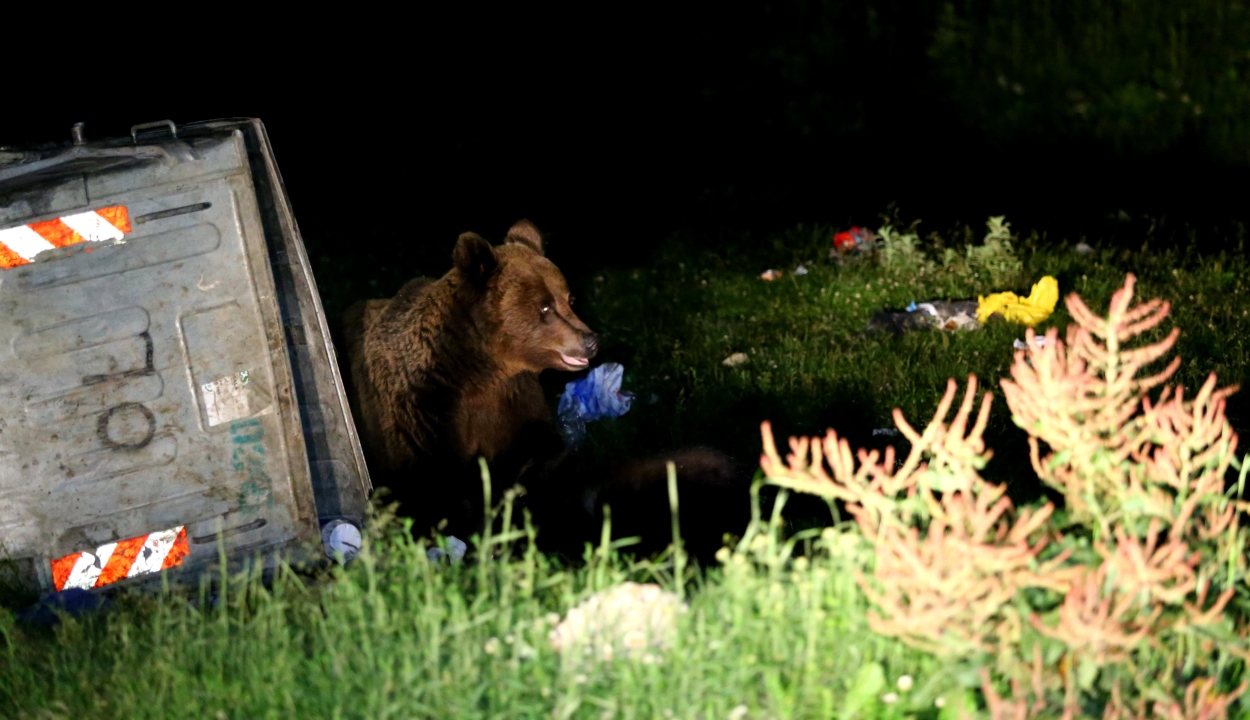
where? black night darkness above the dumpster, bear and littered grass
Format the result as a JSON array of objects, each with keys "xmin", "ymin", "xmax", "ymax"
[{"xmin": 0, "ymin": 0, "xmax": 1250, "ymax": 302}]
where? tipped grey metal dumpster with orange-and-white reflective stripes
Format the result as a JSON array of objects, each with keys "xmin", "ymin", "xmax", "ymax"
[{"xmin": 0, "ymin": 119, "xmax": 370, "ymax": 593}]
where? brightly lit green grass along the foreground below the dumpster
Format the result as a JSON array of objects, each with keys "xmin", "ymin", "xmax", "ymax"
[{"xmin": 0, "ymin": 497, "xmax": 945, "ymax": 719}]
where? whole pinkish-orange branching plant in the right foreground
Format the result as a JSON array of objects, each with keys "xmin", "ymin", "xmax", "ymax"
[{"xmin": 760, "ymin": 275, "xmax": 1250, "ymax": 719}]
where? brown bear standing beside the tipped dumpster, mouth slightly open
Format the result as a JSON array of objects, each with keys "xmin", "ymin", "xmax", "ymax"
[{"xmin": 344, "ymin": 220, "xmax": 598, "ymax": 531}]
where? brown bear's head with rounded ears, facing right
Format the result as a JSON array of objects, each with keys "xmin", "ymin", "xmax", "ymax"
[{"xmin": 453, "ymin": 220, "xmax": 599, "ymax": 374}]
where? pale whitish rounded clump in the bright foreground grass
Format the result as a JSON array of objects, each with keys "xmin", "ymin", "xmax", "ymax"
[{"xmin": 548, "ymin": 583, "xmax": 686, "ymax": 665}]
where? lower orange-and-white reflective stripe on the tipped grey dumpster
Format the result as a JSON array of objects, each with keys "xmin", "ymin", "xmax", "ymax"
[{"xmin": 53, "ymin": 525, "xmax": 191, "ymax": 593}]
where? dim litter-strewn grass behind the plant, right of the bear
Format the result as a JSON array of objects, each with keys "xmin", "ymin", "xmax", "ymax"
[{"xmin": 572, "ymin": 220, "xmax": 1250, "ymax": 499}]
